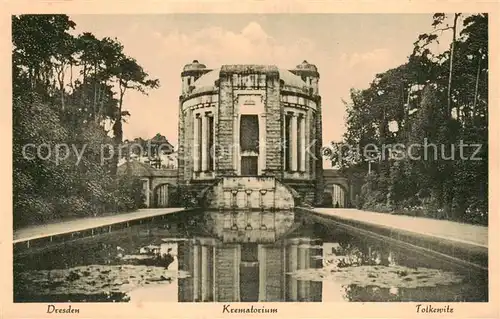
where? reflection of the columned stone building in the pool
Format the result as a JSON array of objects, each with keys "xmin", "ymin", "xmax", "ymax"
[{"xmin": 178, "ymin": 213, "xmax": 322, "ymax": 302}]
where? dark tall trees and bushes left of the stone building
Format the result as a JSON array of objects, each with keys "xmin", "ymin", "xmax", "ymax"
[{"xmin": 12, "ymin": 15, "xmax": 159, "ymax": 227}]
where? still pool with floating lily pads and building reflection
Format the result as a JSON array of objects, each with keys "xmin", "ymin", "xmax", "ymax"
[{"xmin": 14, "ymin": 212, "xmax": 488, "ymax": 302}]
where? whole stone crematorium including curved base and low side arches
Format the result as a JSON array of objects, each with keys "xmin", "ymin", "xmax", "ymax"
[{"xmin": 121, "ymin": 61, "xmax": 360, "ymax": 210}]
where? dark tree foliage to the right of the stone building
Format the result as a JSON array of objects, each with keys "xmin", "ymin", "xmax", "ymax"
[{"xmin": 333, "ymin": 13, "xmax": 488, "ymax": 224}]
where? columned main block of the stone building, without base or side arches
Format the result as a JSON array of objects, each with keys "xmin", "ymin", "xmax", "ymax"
[{"xmin": 178, "ymin": 61, "xmax": 324, "ymax": 205}]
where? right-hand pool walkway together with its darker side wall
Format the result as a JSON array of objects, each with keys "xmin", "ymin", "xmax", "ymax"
[{"xmin": 306, "ymin": 208, "xmax": 488, "ymax": 274}]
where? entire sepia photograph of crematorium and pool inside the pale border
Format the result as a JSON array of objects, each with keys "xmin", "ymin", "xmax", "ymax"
[{"xmin": 5, "ymin": 1, "xmax": 495, "ymax": 318}]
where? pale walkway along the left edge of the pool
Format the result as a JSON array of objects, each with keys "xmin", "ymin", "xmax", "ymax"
[{"xmin": 13, "ymin": 208, "xmax": 189, "ymax": 244}]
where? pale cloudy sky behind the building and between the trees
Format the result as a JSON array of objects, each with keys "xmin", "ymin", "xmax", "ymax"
[{"xmin": 70, "ymin": 14, "xmax": 450, "ymax": 145}]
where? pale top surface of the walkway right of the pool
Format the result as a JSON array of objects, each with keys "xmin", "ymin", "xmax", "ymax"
[{"xmin": 313, "ymin": 208, "xmax": 488, "ymax": 248}]
